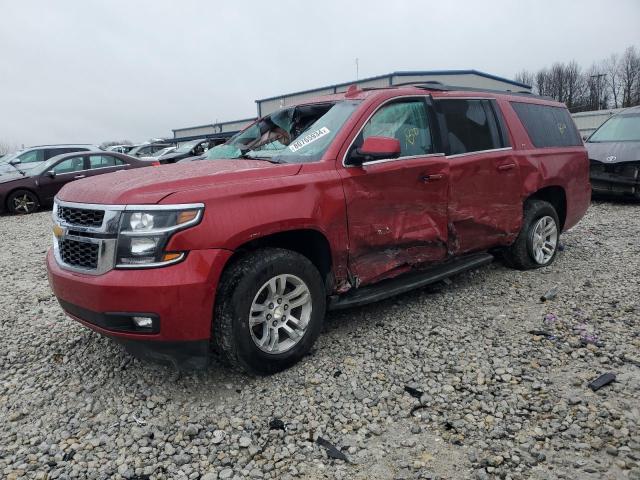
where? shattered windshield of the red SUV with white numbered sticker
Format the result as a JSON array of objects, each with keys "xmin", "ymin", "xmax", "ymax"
[{"xmin": 206, "ymin": 101, "xmax": 360, "ymax": 163}]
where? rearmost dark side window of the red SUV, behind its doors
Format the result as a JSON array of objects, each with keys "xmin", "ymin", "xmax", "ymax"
[{"xmin": 511, "ymin": 102, "xmax": 582, "ymax": 148}]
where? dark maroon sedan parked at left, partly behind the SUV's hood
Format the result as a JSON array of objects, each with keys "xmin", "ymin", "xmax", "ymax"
[{"xmin": 0, "ymin": 151, "xmax": 159, "ymax": 213}]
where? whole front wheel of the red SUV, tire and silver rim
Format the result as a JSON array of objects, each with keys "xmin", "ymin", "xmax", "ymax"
[{"xmin": 212, "ymin": 248, "xmax": 326, "ymax": 374}]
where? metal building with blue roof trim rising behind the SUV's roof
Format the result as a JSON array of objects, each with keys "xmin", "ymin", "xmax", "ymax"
[{"xmin": 256, "ymin": 70, "xmax": 531, "ymax": 117}]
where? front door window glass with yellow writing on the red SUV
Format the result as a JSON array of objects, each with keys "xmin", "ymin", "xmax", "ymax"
[{"xmin": 360, "ymin": 100, "xmax": 433, "ymax": 157}]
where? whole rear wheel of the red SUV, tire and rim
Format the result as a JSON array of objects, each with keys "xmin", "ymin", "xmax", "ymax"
[{"xmin": 504, "ymin": 199, "xmax": 560, "ymax": 270}]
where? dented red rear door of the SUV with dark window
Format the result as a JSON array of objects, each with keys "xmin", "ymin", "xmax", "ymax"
[{"xmin": 435, "ymin": 98, "xmax": 522, "ymax": 255}]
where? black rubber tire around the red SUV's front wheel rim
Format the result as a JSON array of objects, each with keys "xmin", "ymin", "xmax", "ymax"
[{"xmin": 212, "ymin": 248, "xmax": 326, "ymax": 375}]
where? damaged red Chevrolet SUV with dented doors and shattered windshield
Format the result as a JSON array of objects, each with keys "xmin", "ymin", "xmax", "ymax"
[{"xmin": 47, "ymin": 84, "xmax": 591, "ymax": 373}]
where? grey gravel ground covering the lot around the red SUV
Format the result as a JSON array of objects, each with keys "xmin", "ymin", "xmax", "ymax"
[{"xmin": 0, "ymin": 202, "xmax": 640, "ymax": 480}]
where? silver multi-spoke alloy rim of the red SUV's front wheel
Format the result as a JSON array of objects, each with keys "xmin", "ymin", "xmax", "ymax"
[{"xmin": 249, "ymin": 274, "xmax": 312, "ymax": 354}]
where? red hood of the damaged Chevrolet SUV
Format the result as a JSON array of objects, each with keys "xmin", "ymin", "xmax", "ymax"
[{"xmin": 57, "ymin": 160, "xmax": 302, "ymax": 205}]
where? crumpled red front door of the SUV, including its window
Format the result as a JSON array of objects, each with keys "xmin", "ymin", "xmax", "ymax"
[{"xmin": 339, "ymin": 97, "xmax": 449, "ymax": 285}]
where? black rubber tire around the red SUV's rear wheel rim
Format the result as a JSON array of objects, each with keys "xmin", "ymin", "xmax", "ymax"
[{"xmin": 503, "ymin": 199, "xmax": 560, "ymax": 270}]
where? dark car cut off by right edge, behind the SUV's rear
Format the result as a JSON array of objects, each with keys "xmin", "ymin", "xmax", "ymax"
[{"xmin": 585, "ymin": 106, "xmax": 640, "ymax": 200}]
